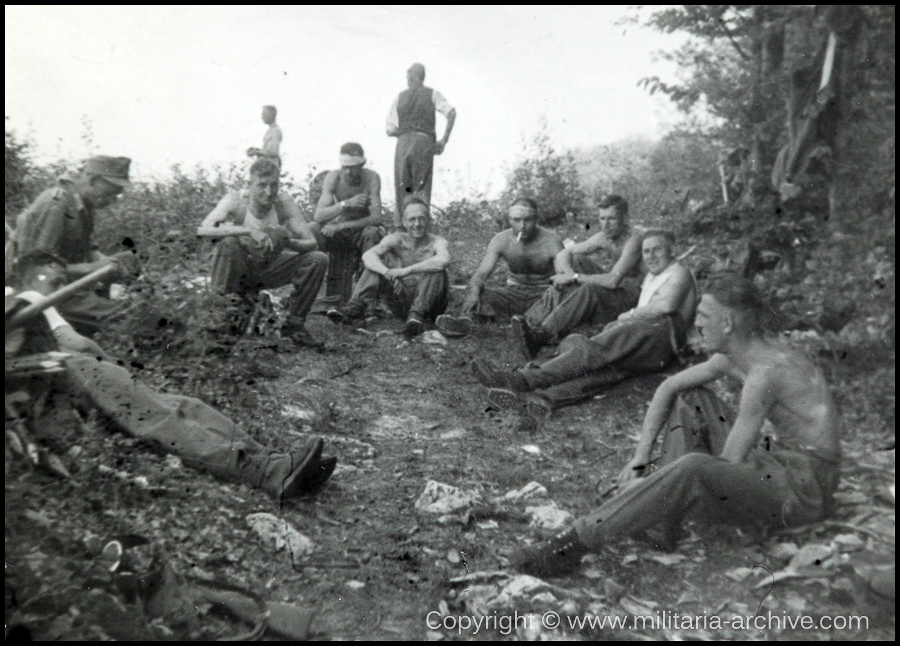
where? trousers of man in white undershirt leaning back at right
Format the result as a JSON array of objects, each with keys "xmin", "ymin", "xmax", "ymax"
[{"xmin": 521, "ymin": 317, "xmax": 675, "ymax": 389}]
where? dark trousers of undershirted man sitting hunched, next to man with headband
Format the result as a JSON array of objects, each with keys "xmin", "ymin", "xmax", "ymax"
[{"xmin": 210, "ymin": 237, "xmax": 328, "ymax": 319}]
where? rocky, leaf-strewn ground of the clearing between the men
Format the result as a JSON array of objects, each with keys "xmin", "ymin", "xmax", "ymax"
[{"xmin": 5, "ymin": 220, "xmax": 894, "ymax": 640}]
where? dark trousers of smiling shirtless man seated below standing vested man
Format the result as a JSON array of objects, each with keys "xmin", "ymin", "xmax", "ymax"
[{"xmin": 347, "ymin": 269, "xmax": 450, "ymax": 321}]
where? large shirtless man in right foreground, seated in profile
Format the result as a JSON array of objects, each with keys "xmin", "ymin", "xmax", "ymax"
[{"xmin": 510, "ymin": 275, "xmax": 840, "ymax": 576}]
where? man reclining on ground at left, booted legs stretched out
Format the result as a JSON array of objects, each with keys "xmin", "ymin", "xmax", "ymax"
[{"xmin": 6, "ymin": 251, "xmax": 337, "ymax": 502}]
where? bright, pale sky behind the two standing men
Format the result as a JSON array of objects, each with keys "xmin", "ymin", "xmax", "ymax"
[{"xmin": 5, "ymin": 6, "xmax": 676, "ymax": 204}]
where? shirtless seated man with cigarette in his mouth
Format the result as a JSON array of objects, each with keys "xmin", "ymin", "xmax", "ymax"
[{"xmin": 437, "ymin": 197, "xmax": 563, "ymax": 337}]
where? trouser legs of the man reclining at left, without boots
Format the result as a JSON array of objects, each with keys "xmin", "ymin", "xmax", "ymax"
[{"xmin": 65, "ymin": 355, "xmax": 263, "ymax": 480}]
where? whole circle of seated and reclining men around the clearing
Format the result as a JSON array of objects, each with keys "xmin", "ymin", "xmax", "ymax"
[{"xmin": 7, "ymin": 62, "xmax": 840, "ymax": 575}]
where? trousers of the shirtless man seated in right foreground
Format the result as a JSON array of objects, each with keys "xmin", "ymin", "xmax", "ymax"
[{"xmin": 575, "ymin": 388, "xmax": 838, "ymax": 550}]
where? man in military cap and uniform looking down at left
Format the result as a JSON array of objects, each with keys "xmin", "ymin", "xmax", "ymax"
[{"xmin": 16, "ymin": 155, "xmax": 140, "ymax": 334}]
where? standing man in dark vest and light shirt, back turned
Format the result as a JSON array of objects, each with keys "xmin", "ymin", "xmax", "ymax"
[{"xmin": 387, "ymin": 63, "xmax": 456, "ymax": 228}]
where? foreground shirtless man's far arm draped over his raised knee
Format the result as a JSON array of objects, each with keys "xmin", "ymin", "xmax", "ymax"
[{"xmin": 619, "ymin": 354, "xmax": 730, "ymax": 484}]
